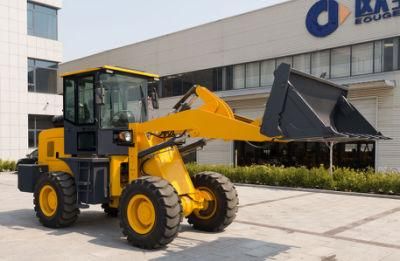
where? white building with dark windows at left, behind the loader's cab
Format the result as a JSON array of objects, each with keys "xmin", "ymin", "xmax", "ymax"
[{"xmin": 0, "ymin": 0, "xmax": 63, "ymax": 160}]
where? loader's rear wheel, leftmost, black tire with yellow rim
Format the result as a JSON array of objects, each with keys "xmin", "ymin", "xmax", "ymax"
[{"xmin": 34, "ymin": 172, "xmax": 79, "ymax": 228}]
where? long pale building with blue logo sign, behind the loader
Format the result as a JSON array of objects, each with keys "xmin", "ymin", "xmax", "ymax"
[{"xmin": 60, "ymin": 0, "xmax": 400, "ymax": 170}]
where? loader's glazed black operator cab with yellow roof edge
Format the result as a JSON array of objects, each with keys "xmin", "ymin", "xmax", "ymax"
[{"xmin": 62, "ymin": 66, "xmax": 158, "ymax": 156}]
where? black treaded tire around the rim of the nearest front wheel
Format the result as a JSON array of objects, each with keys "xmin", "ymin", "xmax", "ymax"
[{"xmin": 119, "ymin": 176, "xmax": 182, "ymax": 249}]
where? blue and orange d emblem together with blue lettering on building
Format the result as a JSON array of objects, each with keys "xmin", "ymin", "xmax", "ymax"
[{"xmin": 306, "ymin": 0, "xmax": 400, "ymax": 37}]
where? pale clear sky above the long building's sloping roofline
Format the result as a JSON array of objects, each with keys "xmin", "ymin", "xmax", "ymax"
[{"xmin": 58, "ymin": 0, "xmax": 285, "ymax": 62}]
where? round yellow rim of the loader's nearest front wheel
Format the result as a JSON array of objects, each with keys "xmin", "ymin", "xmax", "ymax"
[{"xmin": 127, "ymin": 194, "xmax": 156, "ymax": 235}]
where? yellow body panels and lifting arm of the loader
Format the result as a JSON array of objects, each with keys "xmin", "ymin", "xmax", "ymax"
[{"xmin": 39, "ymin": 86, "xmax": 273, "ymax": 216}]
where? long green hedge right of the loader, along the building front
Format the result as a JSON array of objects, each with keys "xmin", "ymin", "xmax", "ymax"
[{"xmin": 187, "ymin": 163, "xmax": 400, "ymax": 195}]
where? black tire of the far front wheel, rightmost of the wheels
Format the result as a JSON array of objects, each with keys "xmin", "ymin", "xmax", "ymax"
[{"xmin": 188, "ymin": 171, "xmax": 239, "ymax": 232}]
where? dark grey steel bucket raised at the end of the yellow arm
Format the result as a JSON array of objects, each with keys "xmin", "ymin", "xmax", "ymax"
[{"xmin": 260, "ymin": 63, "xmax": 388, "ymax": 142}]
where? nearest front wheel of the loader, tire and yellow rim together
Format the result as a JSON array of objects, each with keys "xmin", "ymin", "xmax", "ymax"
[{"xmin": 119, "ymin": 176, "xmax": 182, "ymax": 249}]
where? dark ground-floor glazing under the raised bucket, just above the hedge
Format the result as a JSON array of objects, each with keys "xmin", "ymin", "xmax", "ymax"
[{"xmin": 234, "ymin": 141, "xmax": 375, "ymax": 169}]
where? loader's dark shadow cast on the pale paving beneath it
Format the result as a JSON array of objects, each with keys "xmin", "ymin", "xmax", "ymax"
[{"xmin": 0, "ymin": 209, "xmax": 291, "ymax": 260}]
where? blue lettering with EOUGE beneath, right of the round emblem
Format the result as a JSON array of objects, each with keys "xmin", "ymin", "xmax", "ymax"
[{"xmin": 355, "ymin": 0, "xmax": 400, "ymax": 24}]
